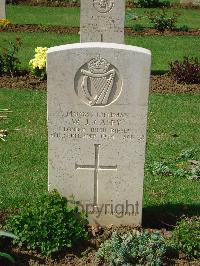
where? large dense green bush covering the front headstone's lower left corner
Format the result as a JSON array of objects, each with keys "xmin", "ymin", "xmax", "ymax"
[{"xmin": 7, "ymin": 191, "xmax": 87, "ymax": 256}]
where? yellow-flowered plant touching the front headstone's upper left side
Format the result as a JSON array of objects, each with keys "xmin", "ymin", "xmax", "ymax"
[{"xmin": 29, "ymin": 47, "xmax": 48, "ymax": 80}]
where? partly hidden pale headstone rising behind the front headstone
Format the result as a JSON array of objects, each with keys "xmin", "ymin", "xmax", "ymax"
[{"xmin": 80, "ymin": 0, "xmax": 125, "ymax": 43}]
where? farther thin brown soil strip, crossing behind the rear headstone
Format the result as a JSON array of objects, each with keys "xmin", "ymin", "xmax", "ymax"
[{"xmin": 0, "ymin": 24, "xmax": 200, "ymax": 36}]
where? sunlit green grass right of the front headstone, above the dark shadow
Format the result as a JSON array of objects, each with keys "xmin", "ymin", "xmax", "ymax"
[{"xmin": 144, "ymin": 94, "xmax": 200, "ymax": 210}]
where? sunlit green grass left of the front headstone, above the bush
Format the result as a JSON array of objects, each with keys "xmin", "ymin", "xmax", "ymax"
[{"xmin": 0, "ymin": 89, "xmax": 47, "ymax": 209}]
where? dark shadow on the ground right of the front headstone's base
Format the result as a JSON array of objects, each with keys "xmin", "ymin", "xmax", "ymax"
[{"xmin": 142, "ymin": 204, "xmax": 200, "ymax": 229}]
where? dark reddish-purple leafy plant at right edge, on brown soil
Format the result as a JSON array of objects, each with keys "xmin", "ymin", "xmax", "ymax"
[{"xmin": 170, "ymin": 57, "xmax": 200, "ymax": 84}]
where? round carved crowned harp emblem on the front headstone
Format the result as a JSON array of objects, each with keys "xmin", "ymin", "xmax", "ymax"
[{"xmin": 75, "ymin": 55, "xmax": 122, "ymax": 106}]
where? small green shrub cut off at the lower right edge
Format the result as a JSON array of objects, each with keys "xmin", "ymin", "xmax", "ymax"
[{"xmin": 173, "ymin": 217, "xmax": 200, "ymax": 259}]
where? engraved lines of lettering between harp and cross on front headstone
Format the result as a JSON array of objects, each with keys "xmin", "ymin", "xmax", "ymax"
[{"xmin": 51, "ymin": 111, "xmax": 144, "ymax": 142}]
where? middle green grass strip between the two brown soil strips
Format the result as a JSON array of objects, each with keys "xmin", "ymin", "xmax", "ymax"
[{"xmin": 0, "ymin": 32, "xmax": 200, "ymax": 71}]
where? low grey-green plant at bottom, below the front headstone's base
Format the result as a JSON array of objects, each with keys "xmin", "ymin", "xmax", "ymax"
[{"xmin": 96, "ymin": 231, "xmax": 171, "ymax": 266}]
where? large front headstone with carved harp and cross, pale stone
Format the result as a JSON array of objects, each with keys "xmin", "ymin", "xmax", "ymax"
[{"xmin": 47, "ymin": 43, "xmax": 151, "ymax": 225}]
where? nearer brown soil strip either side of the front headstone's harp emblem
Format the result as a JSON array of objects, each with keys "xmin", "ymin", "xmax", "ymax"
[{"xmin": 0, "ymin": 73, "xmax": 200, "ymax": 93}]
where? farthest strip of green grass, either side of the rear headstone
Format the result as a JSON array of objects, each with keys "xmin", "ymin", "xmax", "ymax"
[{"xmin": 7, "ymin": 5, "xmax": 200, "ymax": 28}]
